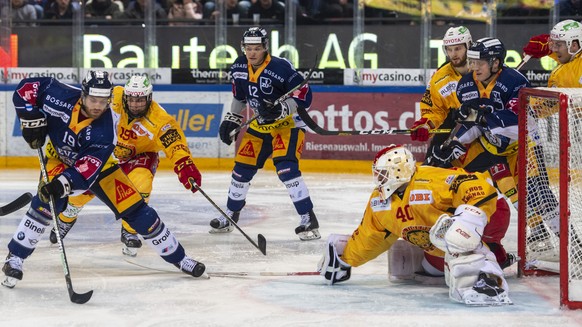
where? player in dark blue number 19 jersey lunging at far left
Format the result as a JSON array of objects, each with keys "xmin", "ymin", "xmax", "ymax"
[{"xmin": 2, "ymin": 71, "xmax": 205, "ymax": 288}]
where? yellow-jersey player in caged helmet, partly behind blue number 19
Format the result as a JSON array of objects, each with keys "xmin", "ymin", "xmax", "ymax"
[{"xmin": 50, "ymin": 75, "xmax": 202, "ymax": 256}]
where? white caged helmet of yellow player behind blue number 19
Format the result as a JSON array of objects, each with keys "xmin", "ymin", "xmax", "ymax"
[{"xmin": 123, "ymin": 75, "xmax": 153, "ymax": 118}]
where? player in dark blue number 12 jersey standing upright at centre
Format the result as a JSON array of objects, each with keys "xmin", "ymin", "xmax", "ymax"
[{"xmin": 216, "ymin": 27, "xmax": 321, "ymax": 240}]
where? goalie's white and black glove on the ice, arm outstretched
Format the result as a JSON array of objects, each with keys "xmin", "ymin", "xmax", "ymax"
[{"xmin": 317, "ymin": 234, "xmax": 352, "ymax": 285}]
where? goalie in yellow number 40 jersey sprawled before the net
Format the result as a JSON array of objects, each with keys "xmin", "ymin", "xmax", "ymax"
[{"xmin": 319, "ymin": 145, "xmax": 512, "ymax": 305}]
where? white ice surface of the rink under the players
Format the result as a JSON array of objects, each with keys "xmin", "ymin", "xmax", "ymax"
[{"xmin": 0, "ymin": 170, "xmax": 582, "ymax": 327}]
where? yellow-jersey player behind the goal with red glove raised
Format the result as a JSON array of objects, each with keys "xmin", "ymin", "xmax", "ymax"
[{"xmin": 523, "ymin": 19, "xmax": 582, "ymax": 87}]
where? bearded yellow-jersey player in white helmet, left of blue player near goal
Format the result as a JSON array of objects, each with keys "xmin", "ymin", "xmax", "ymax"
[{"xmin": 410, "ymin": 26, "xmax": 473, "ymax": 144}]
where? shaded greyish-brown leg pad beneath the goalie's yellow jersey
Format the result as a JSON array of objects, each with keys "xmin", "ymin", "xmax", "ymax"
[{"xmin": 388, "ymin": 238, "xmax": 424, "ymax": 282}]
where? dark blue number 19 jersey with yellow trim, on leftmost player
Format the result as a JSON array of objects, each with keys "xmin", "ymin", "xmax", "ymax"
[{"xmin": 12, "ymin": 77, "xmax": 116, "ymax": 194}]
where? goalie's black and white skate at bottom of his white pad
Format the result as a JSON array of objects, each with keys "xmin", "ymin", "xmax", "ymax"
[{"xmin": 463, "ymin": 273, "xmax": 513, "ymax": 306}]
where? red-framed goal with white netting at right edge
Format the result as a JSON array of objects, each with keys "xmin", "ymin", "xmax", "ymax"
[{"xmin": 518, "ymin": 88, "xmax": 582, "ymax": 309}]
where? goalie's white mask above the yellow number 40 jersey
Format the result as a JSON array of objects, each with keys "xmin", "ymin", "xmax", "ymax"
[{"xmin": 372, "ymin": 144, "xmax": 416, "ymax": 200}]
